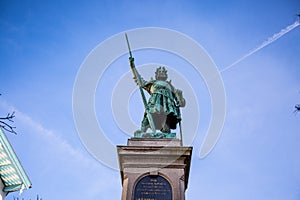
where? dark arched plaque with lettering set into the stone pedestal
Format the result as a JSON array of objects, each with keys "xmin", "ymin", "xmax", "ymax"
[{"xmin": 133, "ymin": 176, "xmax": 172, "ymax": 200}]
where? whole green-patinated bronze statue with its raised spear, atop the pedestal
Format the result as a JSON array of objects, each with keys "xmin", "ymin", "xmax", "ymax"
[{"xmin": 126, "ymin": 35, "xmax": 185, "ymax": 138}]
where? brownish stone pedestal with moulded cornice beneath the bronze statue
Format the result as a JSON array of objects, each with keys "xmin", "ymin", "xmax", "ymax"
[{"xmin": 117, "ymin": 138, "xmax": 192, "ymax": 200}]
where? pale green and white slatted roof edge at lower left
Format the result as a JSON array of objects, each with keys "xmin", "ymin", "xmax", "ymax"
[{"xmin": 0, "ymin": 128, "xmax": 31, "ymax": 192}]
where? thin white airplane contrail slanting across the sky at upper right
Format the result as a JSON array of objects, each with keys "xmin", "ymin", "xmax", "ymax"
[{"xmin": 220, "ymin": 21, "xmax": 300, "ymax": 73}]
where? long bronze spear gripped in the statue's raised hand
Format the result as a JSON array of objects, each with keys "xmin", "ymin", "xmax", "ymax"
[{"xmin": 125, "ymin": 33, "xmax": 156, "ymax": 134}]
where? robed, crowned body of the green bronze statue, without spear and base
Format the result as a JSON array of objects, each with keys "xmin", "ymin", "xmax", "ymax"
[{"xmin": 134, "ymin": 67, "xmax": 185, "ymax": 135}]
